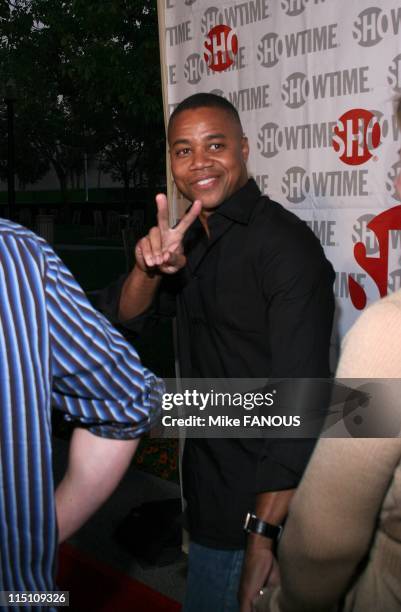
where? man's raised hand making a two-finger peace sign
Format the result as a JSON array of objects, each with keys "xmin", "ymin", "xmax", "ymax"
[{"xmin": 135, "ymin": 193, "xmax": 202, "ymax": 274}]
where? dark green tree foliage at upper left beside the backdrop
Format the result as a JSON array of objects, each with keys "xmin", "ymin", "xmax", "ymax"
[{"xmin": 0, "ymin": 0, "xmax": 163, "ymax": 203}]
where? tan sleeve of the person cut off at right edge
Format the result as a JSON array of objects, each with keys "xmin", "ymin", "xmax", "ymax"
[{"xmin": 257, "ymin": 300, "xmax": 401, "ymax": 612}]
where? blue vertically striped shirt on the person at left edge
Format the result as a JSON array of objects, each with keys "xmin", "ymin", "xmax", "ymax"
[{"xmin": 0, "ymin": 219, "xmax": 163, "ymax": 610}]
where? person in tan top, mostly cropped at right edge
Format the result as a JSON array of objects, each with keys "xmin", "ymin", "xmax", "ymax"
[{"xmin": 254, "ymin": 103, "xmax": 401, "ymax": 612}]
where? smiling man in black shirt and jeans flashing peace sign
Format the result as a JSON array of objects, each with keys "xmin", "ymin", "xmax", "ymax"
[{"xmin": 108, "ymin": 94, "xmax": 334, "ymax": 612}]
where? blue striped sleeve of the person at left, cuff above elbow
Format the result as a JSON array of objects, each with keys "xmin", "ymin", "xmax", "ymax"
[{"xmin": 43, "ymin": 245, "xmax": 164, "ymax": 439}]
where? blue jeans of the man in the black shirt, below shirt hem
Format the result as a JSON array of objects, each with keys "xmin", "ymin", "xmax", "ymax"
[{"xmin": 182, "ymin": 543, "xmax": 244, "ymax": 612}]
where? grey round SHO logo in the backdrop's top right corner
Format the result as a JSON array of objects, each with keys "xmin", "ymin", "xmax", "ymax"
[{"xmin": 353, "ymin": 6, "xmax": 401, "ymax": 47}]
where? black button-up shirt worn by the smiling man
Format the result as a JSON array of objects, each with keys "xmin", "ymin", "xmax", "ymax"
[{"xmin": 97, "ymin": 179, "xmax": 334, "ymax": 549}]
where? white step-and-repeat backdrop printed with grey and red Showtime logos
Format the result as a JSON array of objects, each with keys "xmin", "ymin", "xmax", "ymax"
[{"xmin": 158, "ymin": 0, "xmax": 401, "ymax": 344}]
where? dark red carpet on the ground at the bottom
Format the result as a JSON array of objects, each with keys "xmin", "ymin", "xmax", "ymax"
[{"xmin": 57, "ymin": 544, "xmax": 181, "ymax": 612}]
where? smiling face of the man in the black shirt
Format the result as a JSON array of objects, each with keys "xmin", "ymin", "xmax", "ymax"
[{"xmin": 168, "ymin": 107, "xmax": 249, "ymax": 216}]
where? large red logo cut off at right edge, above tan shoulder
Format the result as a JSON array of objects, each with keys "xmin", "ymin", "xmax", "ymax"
[{"xmin": 348, "ymin": 206, "xmax": 401, "ymax": 310}]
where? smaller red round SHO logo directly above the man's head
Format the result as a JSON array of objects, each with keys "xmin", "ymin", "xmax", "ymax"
[{"xmin": 204, "ymin": 25, "xmax": 238, "ymax": 72}]
